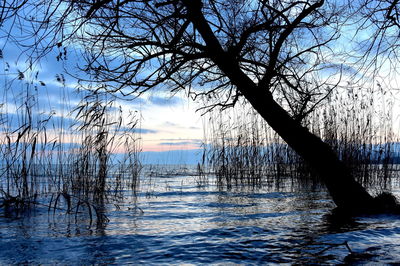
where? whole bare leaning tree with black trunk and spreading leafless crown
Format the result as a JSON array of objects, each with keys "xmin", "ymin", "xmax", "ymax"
[{"xmin": 3, "ymin": 0, "xmax": 397, "ymax": 211}]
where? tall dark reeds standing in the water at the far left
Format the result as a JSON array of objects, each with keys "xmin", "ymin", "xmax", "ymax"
[{"xmin": 0, "ymin": 69, "xmax": 141, "ymax": 220}]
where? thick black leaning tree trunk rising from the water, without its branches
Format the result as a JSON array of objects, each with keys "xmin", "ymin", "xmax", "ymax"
[{"xmin": 183, "ymin": 0, "xmax": 375, "ymax": 212}]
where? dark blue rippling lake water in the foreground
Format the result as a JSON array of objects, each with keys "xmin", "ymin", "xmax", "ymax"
[{"xmin": 0, "ymin": 166, "xmax": 400, "ymax": 265}]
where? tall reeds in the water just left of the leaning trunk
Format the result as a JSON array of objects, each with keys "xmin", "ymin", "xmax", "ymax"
[{"xmin": 205, "ymin": 108, "xmax": 299, "ymax": 188}]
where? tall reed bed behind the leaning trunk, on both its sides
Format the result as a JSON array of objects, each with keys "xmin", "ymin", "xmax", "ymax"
[{"xmin": 205, "ymin": 85, "xmax": 400, "ymax": 190}]
